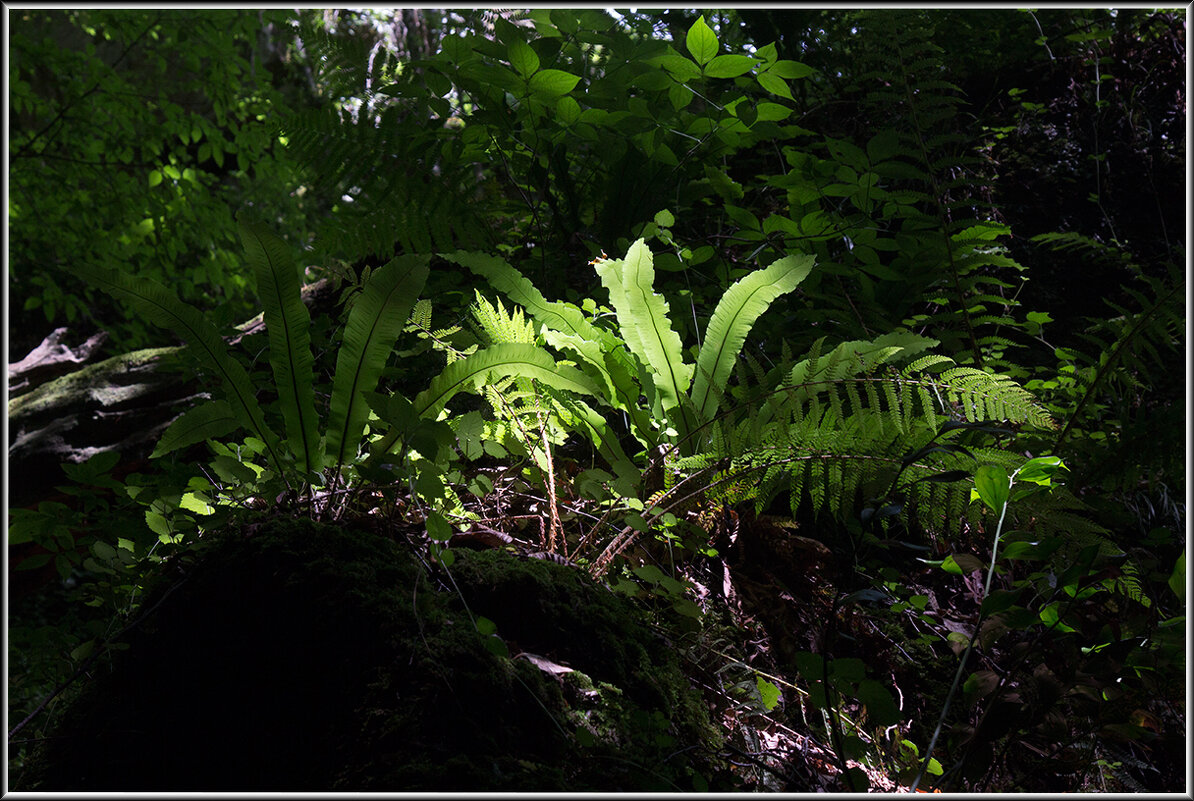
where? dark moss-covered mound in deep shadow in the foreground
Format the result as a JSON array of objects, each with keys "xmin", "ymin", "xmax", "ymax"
[{"xmin": 21, "ymin": 520, "xmax": 716, "ymax": 791}]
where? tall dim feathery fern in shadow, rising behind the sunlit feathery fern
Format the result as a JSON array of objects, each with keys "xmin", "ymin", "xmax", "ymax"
[{"xmin": 858, "ymin": 11, "xmax": 1026, "ymax": 377}]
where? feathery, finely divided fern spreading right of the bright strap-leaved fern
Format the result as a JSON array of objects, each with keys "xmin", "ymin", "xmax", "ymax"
[{"xmin": 672, "ymin": 348, "xmax": 1057, "ymax": 531}]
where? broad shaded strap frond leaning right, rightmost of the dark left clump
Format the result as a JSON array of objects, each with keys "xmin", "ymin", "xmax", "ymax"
[{"xmin": 327, "ymin": 254, "xmax": 429, "ymax": 466}]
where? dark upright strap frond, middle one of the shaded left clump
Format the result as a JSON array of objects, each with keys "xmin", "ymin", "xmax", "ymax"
[{"xmin": 239, "ymin": 220, "xmax": 322, "ymax": 476}]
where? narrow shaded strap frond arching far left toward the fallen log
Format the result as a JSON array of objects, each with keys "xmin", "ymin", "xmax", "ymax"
[{"xmin": 75, "ymin": 265, "xmax": 282, "ymax": 474}]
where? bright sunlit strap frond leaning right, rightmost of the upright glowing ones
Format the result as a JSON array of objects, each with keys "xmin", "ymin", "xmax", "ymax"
[{"xmin": 693, "ymin": 254, "xmax": 814, "ymax": 421}]
